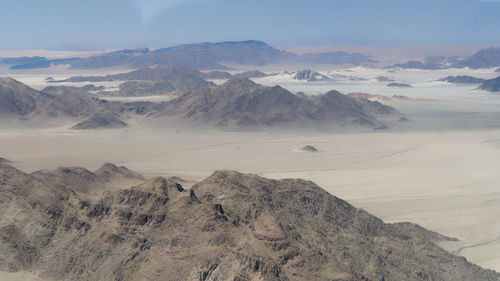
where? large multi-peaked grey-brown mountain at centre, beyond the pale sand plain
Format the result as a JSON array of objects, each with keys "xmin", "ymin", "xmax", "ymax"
[{"xmin": 156, "ymin": 78, "xmax": 396, "ymax": 127}]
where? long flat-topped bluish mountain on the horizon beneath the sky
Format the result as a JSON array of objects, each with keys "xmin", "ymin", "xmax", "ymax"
[{"xmin": 3, "ymin": 40, "xmax": 376, "ymax": 70}]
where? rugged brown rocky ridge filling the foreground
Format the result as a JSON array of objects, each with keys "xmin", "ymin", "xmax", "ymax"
[{"xmin": 0, "ymin": 164, "xmax": 500, "ymax": 281}]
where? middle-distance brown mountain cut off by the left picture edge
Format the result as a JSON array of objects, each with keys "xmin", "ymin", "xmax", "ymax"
[{"xmin": 0, "ymin": 78, "xmax": 52, "ymax": 117}]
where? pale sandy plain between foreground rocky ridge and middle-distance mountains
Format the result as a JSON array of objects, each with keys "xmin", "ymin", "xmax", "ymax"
[{"xmin": 0, "ymin": 128, "xmax": 500, "ymax": 270}]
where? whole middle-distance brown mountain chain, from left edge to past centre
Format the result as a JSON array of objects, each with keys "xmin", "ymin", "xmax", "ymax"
[{"xmin": 0, "ymin": 75, "xmax": 399, "ymax": 129}]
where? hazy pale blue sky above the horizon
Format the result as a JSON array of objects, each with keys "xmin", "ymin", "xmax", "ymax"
[{"xmin": 0, "ymin": 0, "xmax": 500, "ymax": 50}]
